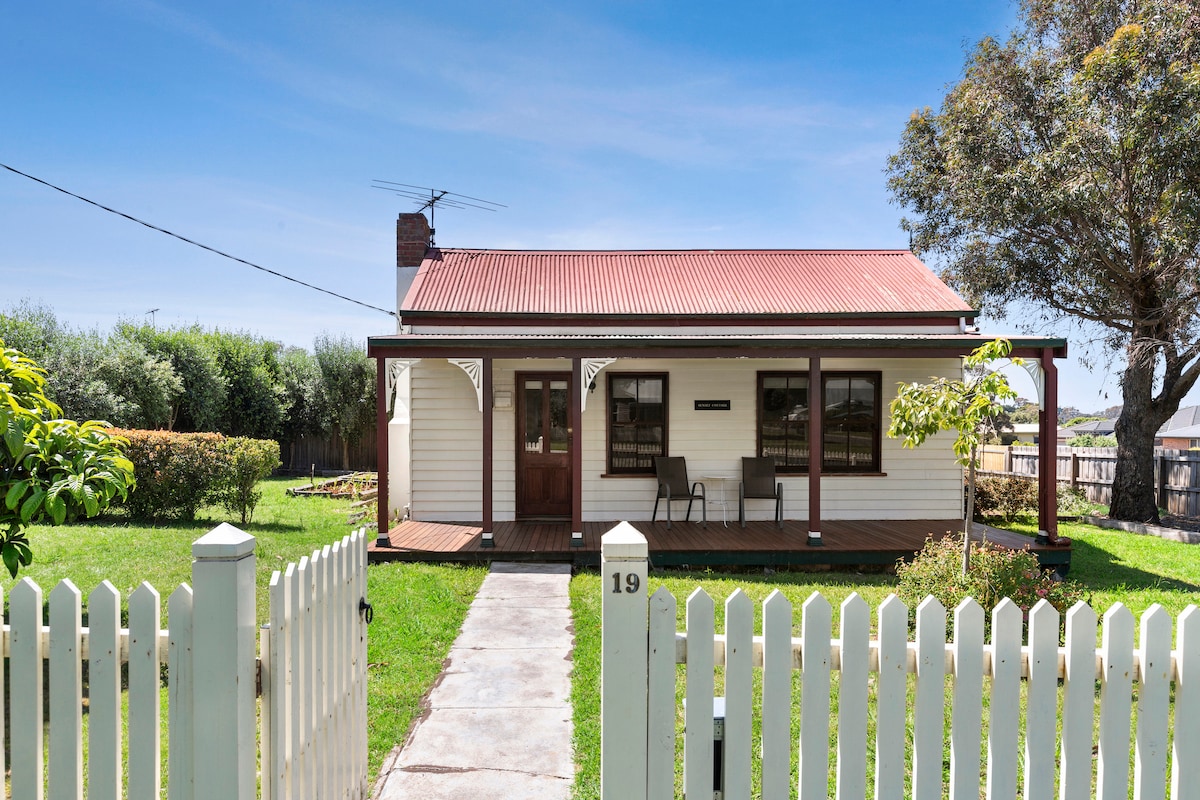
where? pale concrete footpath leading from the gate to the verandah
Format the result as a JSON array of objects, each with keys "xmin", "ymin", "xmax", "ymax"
[{"xmin": 372, "ymin": 563, "xmax": 575, "ymax": 800}]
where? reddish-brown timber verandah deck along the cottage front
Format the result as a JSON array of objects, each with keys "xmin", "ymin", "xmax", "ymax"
[{"xmin": 367, "ymin": 519, "xmax": 1070, "ymax": 572}]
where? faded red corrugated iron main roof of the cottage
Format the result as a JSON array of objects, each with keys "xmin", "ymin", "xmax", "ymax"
[{"xmin": 401, "ymin": 248, "xmax": 973, "ymax": 317}]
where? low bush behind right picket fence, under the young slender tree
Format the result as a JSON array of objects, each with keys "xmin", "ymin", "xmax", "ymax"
[{"xmin": 896, "ymin": 536, "xmax": 1085, "ymax": 626}]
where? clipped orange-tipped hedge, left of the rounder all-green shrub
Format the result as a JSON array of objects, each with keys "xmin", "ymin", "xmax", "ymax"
[{"xmin": 116, "ymin": 431, "xmax": 227, "ymax": 521}]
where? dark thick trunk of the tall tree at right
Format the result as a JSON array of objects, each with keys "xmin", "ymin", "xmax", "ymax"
[{"xmin": 1109, "ymin": 359, "xmax": 1164, "ymax": 523}]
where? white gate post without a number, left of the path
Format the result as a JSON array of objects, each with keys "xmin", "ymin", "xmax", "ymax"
[{"xmin": 192, "ymin": 523, "xmax": 258, "ymax": 800}]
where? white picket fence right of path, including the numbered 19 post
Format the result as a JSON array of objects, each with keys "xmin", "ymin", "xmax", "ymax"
[{"xmin": 600, "ymin": 523, "xmax": 1200, "ymax": 800}]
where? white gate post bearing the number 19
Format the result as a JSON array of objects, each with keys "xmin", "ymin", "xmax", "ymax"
[{"xmin": 600, "ymin": 522, "xmax": 649, "ymax": 800}]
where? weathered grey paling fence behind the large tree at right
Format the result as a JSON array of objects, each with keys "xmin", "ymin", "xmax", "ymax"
[{"xmin": 980, "ymin": 445, "xmax": 1200, "ymax": 517}]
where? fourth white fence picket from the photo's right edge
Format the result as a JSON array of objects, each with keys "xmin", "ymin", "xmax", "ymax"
[{"xmin": 1058, "ymin": 601, "xmax": 1097, "ymax": 800}]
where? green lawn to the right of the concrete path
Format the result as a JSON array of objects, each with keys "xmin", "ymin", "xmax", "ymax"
[{"xmin": 571, "ymin": 524, "xmax": 1200, "ymax": 799}]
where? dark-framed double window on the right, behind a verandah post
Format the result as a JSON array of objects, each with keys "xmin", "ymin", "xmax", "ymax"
[{"xmin": 758, "ymin": 372, "xmax": 883, "ymax": 473}]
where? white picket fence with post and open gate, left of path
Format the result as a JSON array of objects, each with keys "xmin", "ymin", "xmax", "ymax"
[{"xmin": 0, "ymin": 524, "xmax": 368, "ymax": 800}]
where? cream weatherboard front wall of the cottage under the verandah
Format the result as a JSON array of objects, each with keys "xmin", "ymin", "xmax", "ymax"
[{"xmin": 412, "ymin": 359, "xmax": 962, "ymax": 522}]
